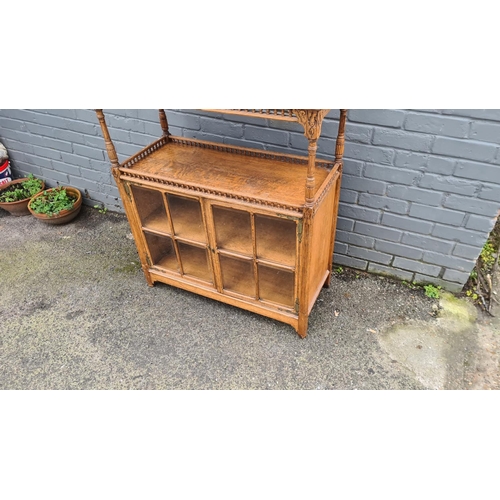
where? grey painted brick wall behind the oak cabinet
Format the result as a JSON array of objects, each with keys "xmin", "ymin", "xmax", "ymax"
[{"xmin": 0, "ymin": 109, "xmax": 500, "ymax": 291}]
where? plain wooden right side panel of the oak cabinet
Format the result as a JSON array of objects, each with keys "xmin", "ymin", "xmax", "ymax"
[{"xmin": 308, "ymin": 183, "xmax": 336, "ymax": 311}]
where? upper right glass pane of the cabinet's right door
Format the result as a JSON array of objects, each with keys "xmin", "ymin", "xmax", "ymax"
[{"xmin": 255, "ymin": 215, "xmax": 296, "ymax": 266}]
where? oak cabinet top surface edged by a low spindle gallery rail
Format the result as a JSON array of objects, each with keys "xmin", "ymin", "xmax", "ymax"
[{"xmin": 120, "ymin": 136, "xmax": 338, "ymax": 210}]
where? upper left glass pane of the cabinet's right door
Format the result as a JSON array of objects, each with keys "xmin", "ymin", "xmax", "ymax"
[{"xmin": 213, "ymin": 207, "xmax": 253, "ymax": 255}]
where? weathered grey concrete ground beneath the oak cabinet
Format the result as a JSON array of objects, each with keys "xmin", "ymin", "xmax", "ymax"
[{"xmin": 0, "ymin": 207, "xmax": 500, "ymax": 390}]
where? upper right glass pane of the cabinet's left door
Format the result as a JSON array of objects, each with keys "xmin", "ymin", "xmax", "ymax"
[{"xmin": 167, "ymin": 194, "xmax": 207, "ymax": 242}]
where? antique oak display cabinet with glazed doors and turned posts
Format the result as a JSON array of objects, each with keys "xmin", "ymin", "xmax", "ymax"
[{"xmin": 96, "ymin": 109, "xmax": 346, "ymax": 337}]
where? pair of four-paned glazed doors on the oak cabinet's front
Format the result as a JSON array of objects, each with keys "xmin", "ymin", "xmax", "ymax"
[{"xmin": 130, "ymin": 185, "xmax": 300, "ymax": 309}]
